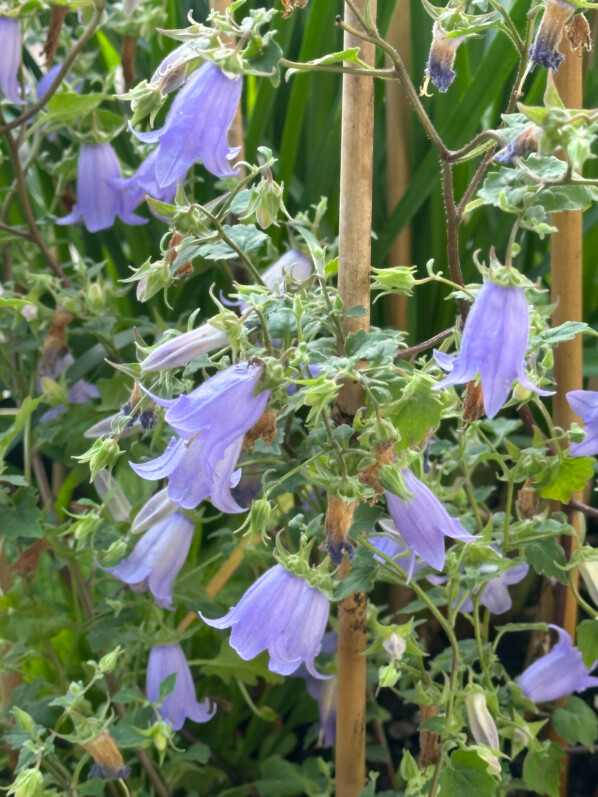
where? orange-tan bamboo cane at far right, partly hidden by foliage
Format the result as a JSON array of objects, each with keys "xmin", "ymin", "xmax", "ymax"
[{"xmin": 550, "ymin": 28, "xmax": 583, "ymax": 796}]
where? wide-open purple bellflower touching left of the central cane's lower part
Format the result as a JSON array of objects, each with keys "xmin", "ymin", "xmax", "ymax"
[{"xmin": 200, "ymin": 565, "xmax": 329, "ymax": 678}]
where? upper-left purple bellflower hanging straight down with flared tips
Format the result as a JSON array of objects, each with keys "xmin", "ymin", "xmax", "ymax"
[{"xmin": 56, "ymin": 144, "xmax": 147, "ymax": 232}]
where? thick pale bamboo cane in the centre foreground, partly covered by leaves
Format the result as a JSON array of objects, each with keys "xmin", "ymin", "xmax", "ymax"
[{"xmin": 335, "ymin": 0, "xmax": 376, "ymax": 797}]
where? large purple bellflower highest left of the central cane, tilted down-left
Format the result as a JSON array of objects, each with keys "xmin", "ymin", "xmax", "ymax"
[{"xmin": 133, "ymin": 63, "xmax": 242, "ymax": 188}]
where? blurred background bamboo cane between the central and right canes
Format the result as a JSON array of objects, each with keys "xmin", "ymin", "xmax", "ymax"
[{"xmin": 386, "ymin": 0, "xmax": 411, "ymax": 329}]
